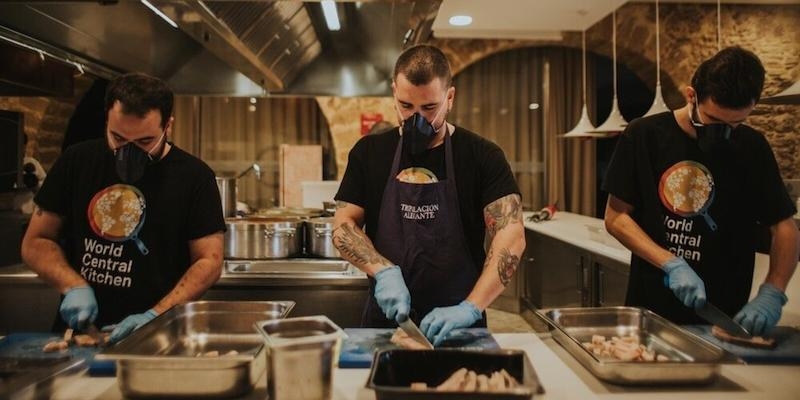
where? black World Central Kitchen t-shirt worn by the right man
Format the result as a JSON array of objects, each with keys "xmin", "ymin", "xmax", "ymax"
[{"xmin": 603, "ymin": 112, "xmax": 795, "ymax": 324}]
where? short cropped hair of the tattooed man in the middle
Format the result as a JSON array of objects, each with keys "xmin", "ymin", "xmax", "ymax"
[{"xmin": 392, "ymin": 44, "xmax": 452, "ymax": 87}]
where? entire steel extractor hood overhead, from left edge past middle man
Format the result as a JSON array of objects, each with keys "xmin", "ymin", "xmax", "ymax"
[{"xmin": 0, "ymin": 0, "xmax": 441, "ymax": 96}]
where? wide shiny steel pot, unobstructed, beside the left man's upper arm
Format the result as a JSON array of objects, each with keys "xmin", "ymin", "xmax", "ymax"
[{"xmin": 224, "ymin": 218, "xmax": 303, "ymax": 260}]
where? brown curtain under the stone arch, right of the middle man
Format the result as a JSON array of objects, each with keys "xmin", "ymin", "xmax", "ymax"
[{"xmin": 449, "ymin": 47, "xmax": 596, "ymax": 215}]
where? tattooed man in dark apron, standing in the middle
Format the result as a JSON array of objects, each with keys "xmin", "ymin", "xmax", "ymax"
[{"xmin": 333, "ymin": 45, "xmax": 525, "ymax": 345}]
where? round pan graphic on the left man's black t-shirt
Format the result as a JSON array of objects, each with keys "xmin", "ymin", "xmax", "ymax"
[{"xmin": 87, "ymin": 184, "xmax": 150, "ymax": 255}]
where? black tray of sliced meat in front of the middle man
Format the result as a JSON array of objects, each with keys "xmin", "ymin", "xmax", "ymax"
[{"xmin": 367, "ymin": 349, "xmax": 544, "ymax": 400}]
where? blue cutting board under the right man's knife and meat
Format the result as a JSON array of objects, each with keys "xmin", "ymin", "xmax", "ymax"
[{"xmin": 684, "ymin": 325, "xmax": 800, "ymax": 364}]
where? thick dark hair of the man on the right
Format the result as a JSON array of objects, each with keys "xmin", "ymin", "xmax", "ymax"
[{"xmin": 692, "ymin": 46, "xmax": 764, "ymax": 109}]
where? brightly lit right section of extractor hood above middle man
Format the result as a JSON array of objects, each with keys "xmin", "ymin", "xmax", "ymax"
[{"xmin": 154, "ymin": 0, "xmax": 441, "ymax": 96}]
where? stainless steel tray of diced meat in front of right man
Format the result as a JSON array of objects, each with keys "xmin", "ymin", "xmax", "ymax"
[{"xmin": 536, "ymin": 307, "xmax": 728, "ymax": 385}]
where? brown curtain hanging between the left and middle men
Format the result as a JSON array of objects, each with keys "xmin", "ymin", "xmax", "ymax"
[{"xmin": 173, "ymin": 97, "xmax": 336, "ymax": 208}]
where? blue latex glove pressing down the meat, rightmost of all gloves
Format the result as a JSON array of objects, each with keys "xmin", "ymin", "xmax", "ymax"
[{"xmin": 733, "ymin": 283, "xmax": 789, "ymax": 336}]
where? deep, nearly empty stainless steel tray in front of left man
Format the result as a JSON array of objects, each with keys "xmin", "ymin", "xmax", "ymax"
[{"xmin": 95, "ymin": 301, "xmax": 295, "ymax": 398}]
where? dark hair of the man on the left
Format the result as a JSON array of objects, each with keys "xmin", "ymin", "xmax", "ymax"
[{"xmin": 105, "ymin": 72, "xmax": 174, "ymax": 128}]
